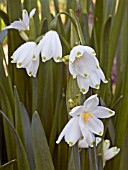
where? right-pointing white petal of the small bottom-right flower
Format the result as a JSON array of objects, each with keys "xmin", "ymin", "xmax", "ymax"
[{"xmin": 104, "ymin": 147, "xmax": 120, "ymax": 161}]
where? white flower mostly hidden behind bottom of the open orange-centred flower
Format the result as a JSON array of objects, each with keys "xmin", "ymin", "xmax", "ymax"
[{"xmin": 78, "ymin": 136, "xmax": 102, "ymax": 148}]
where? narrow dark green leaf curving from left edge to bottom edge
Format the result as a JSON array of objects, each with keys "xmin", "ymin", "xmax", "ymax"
[{"xmin": 0, "ymin": 111, "xmax": 30, "ymax": 170}]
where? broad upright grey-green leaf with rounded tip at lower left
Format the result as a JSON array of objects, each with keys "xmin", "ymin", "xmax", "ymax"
[{"xmin": 32, "ymin": 112, "xmax": 54, "ymax": 170}]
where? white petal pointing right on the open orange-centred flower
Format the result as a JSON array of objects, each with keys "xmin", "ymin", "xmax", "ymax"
[{"xmin": 91, "ymin": 106, "xmax": 115, "ymax": 118}]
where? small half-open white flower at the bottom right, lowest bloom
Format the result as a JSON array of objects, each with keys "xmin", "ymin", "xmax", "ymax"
[{"xmin": 103, "ymin": 139, "xmax": 120, "ymax": 167}]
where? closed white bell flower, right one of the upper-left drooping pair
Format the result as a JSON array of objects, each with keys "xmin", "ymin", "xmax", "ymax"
[{"xmin": 38, "ymin": 31, "xmax": 62, "ymax": 62}]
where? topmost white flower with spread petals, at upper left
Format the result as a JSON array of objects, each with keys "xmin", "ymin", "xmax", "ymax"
[{"xmin": 4, "ymin": 8, "xmax": 36, "ymax": 31}]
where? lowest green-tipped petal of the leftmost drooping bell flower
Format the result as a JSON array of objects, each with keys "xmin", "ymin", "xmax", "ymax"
[{"xmin": 26, "ymin": 57, "xmax": 39, "ymax": 77}]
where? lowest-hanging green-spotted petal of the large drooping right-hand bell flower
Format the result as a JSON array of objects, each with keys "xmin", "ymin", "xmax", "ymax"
[{"xmin": 77, "ymin": 75, "xmax": 89, "ymax": 94}]
